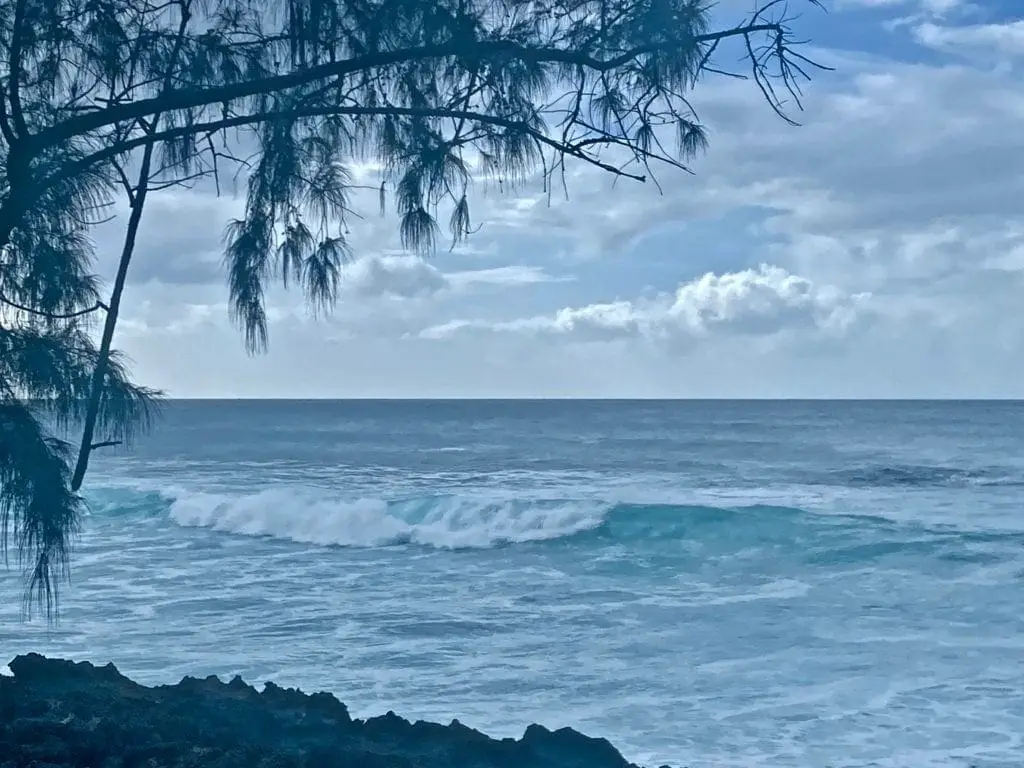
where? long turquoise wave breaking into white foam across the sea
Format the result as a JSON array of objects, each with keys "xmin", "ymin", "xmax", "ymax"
[{"xmin": 83, "ymin": 486, "xmax": 1024, "ymax": 556}]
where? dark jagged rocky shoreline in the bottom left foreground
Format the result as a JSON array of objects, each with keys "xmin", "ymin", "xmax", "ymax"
[{"xmin": 0, "ymin": 653, "xmax": 667, "ymax": 768}]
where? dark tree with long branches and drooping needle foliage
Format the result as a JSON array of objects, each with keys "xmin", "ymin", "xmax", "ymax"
[{"xmin": 0, "ymin": 0, "xmax": 817, "ymax": 618}]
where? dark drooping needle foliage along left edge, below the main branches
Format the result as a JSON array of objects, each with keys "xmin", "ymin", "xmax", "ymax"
[{"xmin": 0, "ymin": 107, "xmax": 156, "ymax": 610}]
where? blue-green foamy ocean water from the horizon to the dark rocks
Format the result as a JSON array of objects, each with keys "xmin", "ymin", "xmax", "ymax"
[{"xmin": 0, "ymin": 401, "xmax": 1024, "ymax": 768}]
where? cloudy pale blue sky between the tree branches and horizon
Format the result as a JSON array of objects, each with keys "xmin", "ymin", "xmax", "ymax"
[{"xmin": 88, "ymin": 0, "xmax": 1024, "ymax": 398}]
